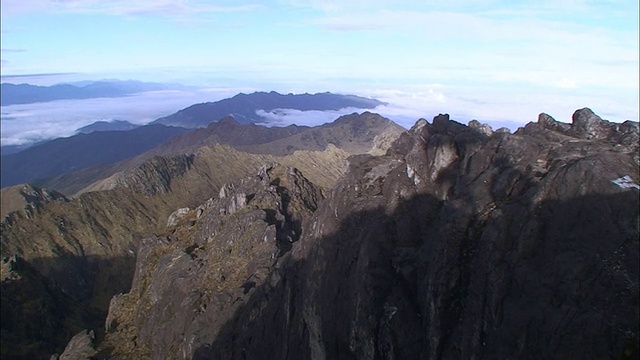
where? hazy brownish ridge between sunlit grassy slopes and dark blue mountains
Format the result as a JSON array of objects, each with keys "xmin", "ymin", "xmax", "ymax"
[{"xmin": 35, "ymin": 112, "xmax": 405, "ymax": 196}]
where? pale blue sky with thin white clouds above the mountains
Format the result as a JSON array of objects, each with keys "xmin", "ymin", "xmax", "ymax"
[{"xmin": 0, "ymin": 0, "xmax": 640, "ymax": 143}]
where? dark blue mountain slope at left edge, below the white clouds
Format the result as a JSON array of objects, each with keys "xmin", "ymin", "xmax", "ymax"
[{"xmin": 0, "ymin": 124, "xmax": 188, "ymax": 187}]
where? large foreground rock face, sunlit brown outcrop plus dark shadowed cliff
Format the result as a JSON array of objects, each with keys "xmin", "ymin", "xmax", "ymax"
[{"xmin": 99, "ymin": 109, "xmax": 640, "ymax": 359}]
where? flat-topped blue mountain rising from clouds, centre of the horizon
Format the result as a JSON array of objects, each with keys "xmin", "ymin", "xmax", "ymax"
[{"xmin": 152, "ymin": 91, "xmax": 385, "ymax": 128}]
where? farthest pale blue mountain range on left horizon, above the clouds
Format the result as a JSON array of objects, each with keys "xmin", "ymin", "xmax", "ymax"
[{"xmin": 0, "ymin": 80, "xmax": 190, "ymax": 106}]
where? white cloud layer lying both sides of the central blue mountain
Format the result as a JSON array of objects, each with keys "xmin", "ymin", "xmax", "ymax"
[{"xmin": 1, "ymin": 84, "xmax": 638, "ymax": 146}]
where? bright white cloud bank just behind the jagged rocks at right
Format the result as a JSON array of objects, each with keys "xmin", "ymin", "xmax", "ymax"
[{"xmin": 359, "ymin": 84, "xmax": 639, "ymax": 131}]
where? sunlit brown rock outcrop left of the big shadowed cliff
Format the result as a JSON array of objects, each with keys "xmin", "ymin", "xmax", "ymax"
[{"xmin": 101, "ymin": 165, "xmax": 322, "ymax": 359}]
